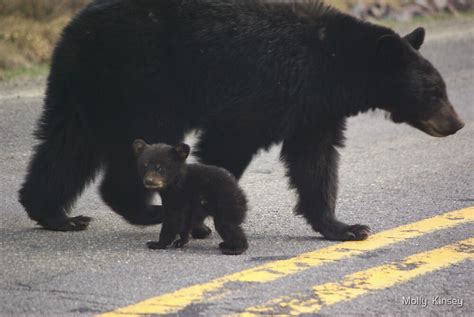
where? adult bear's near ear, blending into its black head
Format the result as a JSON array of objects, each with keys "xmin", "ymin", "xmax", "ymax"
[{"xmin": 376, "ymin": 34, "xmax": 405, "ymax": 67}]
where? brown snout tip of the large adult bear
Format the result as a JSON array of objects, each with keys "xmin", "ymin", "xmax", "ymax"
[{"xmin": 421, "ymin": 103, "xmax": 464, "ymax": 137}]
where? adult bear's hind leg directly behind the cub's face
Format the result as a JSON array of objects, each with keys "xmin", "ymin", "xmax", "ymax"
[{"xmin": 100, "ymin": 152, "xmax": 162, "ymax": 225}]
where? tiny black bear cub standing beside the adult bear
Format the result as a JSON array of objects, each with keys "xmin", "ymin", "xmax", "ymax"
[{"xmin": 133, "ymin": 140, "xmax": 248, "ymax": 254}]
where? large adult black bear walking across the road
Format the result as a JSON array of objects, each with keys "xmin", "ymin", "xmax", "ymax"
[{"xmin": 20, "ymin": 0, "xmax": 463, "ymax": 240}]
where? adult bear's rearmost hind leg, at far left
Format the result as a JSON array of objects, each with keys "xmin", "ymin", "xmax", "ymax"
[{"xmin": 19, "ymin": 132, "xmax": 100, "ymax": 231}]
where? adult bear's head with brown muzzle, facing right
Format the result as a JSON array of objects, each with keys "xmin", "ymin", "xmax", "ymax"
[{"xmin": 372, "ymin": 28, "xmax": 464, "ymax": 137}]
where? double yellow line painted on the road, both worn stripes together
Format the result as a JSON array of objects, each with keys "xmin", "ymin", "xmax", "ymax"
[{"xmin": 100, "ymin": 207, "xmax": 474, "ymax": 317}]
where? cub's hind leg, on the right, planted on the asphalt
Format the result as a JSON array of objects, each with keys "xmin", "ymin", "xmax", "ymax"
[{"xmin": 214, "ymin": 217, "xmax": 249, "ymax": 255}]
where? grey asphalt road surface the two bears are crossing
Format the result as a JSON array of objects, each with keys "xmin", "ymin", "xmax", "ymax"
[{"xmin": 0, "ymin": 22, "xmax": 474, "ymax": 316}]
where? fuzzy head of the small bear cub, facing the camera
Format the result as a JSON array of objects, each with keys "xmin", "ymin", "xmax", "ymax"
[{"xmin": 133, "ymin": 140, "xmax": 190, "ymax": 191}]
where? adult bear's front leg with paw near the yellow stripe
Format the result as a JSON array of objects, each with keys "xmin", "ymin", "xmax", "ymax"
[{"xmin": 281, "ymin": 123, "xmax": 370, "ymax": 241}]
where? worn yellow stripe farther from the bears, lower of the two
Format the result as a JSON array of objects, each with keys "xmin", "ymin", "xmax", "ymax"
[{"xmin": 239, "ymin": 238, "xmax": 474, "ymax": 317}]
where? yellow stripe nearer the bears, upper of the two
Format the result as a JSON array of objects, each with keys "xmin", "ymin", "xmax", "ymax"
[{"xmin": 100, "ymin": 207, "xmax": 474, "ymax": 317}]
